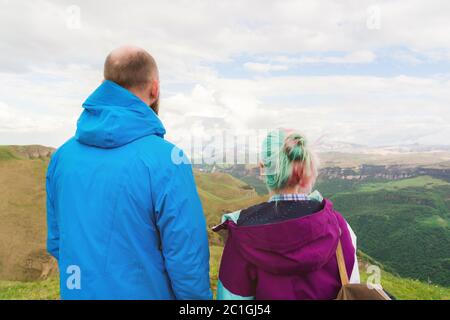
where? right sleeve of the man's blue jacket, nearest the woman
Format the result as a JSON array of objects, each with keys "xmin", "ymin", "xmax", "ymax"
[{"xmin": 153, "ymin": 155, "xmax": 212, "ymax": 300}]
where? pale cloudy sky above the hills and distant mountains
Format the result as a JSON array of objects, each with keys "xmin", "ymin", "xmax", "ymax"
[{"xmin": 0, "ymin": 0, "xmax": 450, "ymax": 151}]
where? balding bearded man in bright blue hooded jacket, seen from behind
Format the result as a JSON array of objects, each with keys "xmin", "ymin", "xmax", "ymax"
[{"xmin": 47, "ymin": 47, "xmax": 212, "ymax": 299}]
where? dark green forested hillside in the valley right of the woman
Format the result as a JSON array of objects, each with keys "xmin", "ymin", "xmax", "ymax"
[{"xmin": 318, "ymin": 176, "xmax": 450, "ymax": 286}]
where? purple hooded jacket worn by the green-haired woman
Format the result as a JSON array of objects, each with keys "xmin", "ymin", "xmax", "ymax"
[{"xmin": 216, "ymin": 199, "xmax": 357, "ymax": 300}]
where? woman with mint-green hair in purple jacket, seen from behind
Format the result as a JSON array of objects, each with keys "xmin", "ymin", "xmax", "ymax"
[{"xmin": 215, "ymin": 130, "xmax": 359, "ymax": 300}]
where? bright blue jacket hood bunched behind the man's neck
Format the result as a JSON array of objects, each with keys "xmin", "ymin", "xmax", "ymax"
[{"xmin": 75, "ymin": 80, "xmax": 166, "ymax": 148}]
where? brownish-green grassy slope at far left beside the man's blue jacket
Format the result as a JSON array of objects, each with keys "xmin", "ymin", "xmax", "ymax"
[{"xmin": 0, "ymin": 146, "xmax": 55, "ymax": 280}]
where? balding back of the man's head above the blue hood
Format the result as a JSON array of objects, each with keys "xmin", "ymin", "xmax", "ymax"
[{"xmin": 104, "ymin": 46, "xmax": 158, "ymax": 90}]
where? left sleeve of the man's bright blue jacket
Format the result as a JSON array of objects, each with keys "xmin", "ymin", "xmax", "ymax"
[{"xmin": 46, "ymin": 155, "xmax": 59, "ymax": 260}]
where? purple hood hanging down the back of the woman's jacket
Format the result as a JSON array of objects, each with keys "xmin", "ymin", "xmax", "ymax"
[{"xmin": 225, "ymin": 199, "xmax": 340, "ymax": 275}]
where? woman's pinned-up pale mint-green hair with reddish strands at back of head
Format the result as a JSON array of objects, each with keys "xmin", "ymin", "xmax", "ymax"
[{"xmin": 261, "ymin": 129, "xmax": 317, "ymax": 190}]
